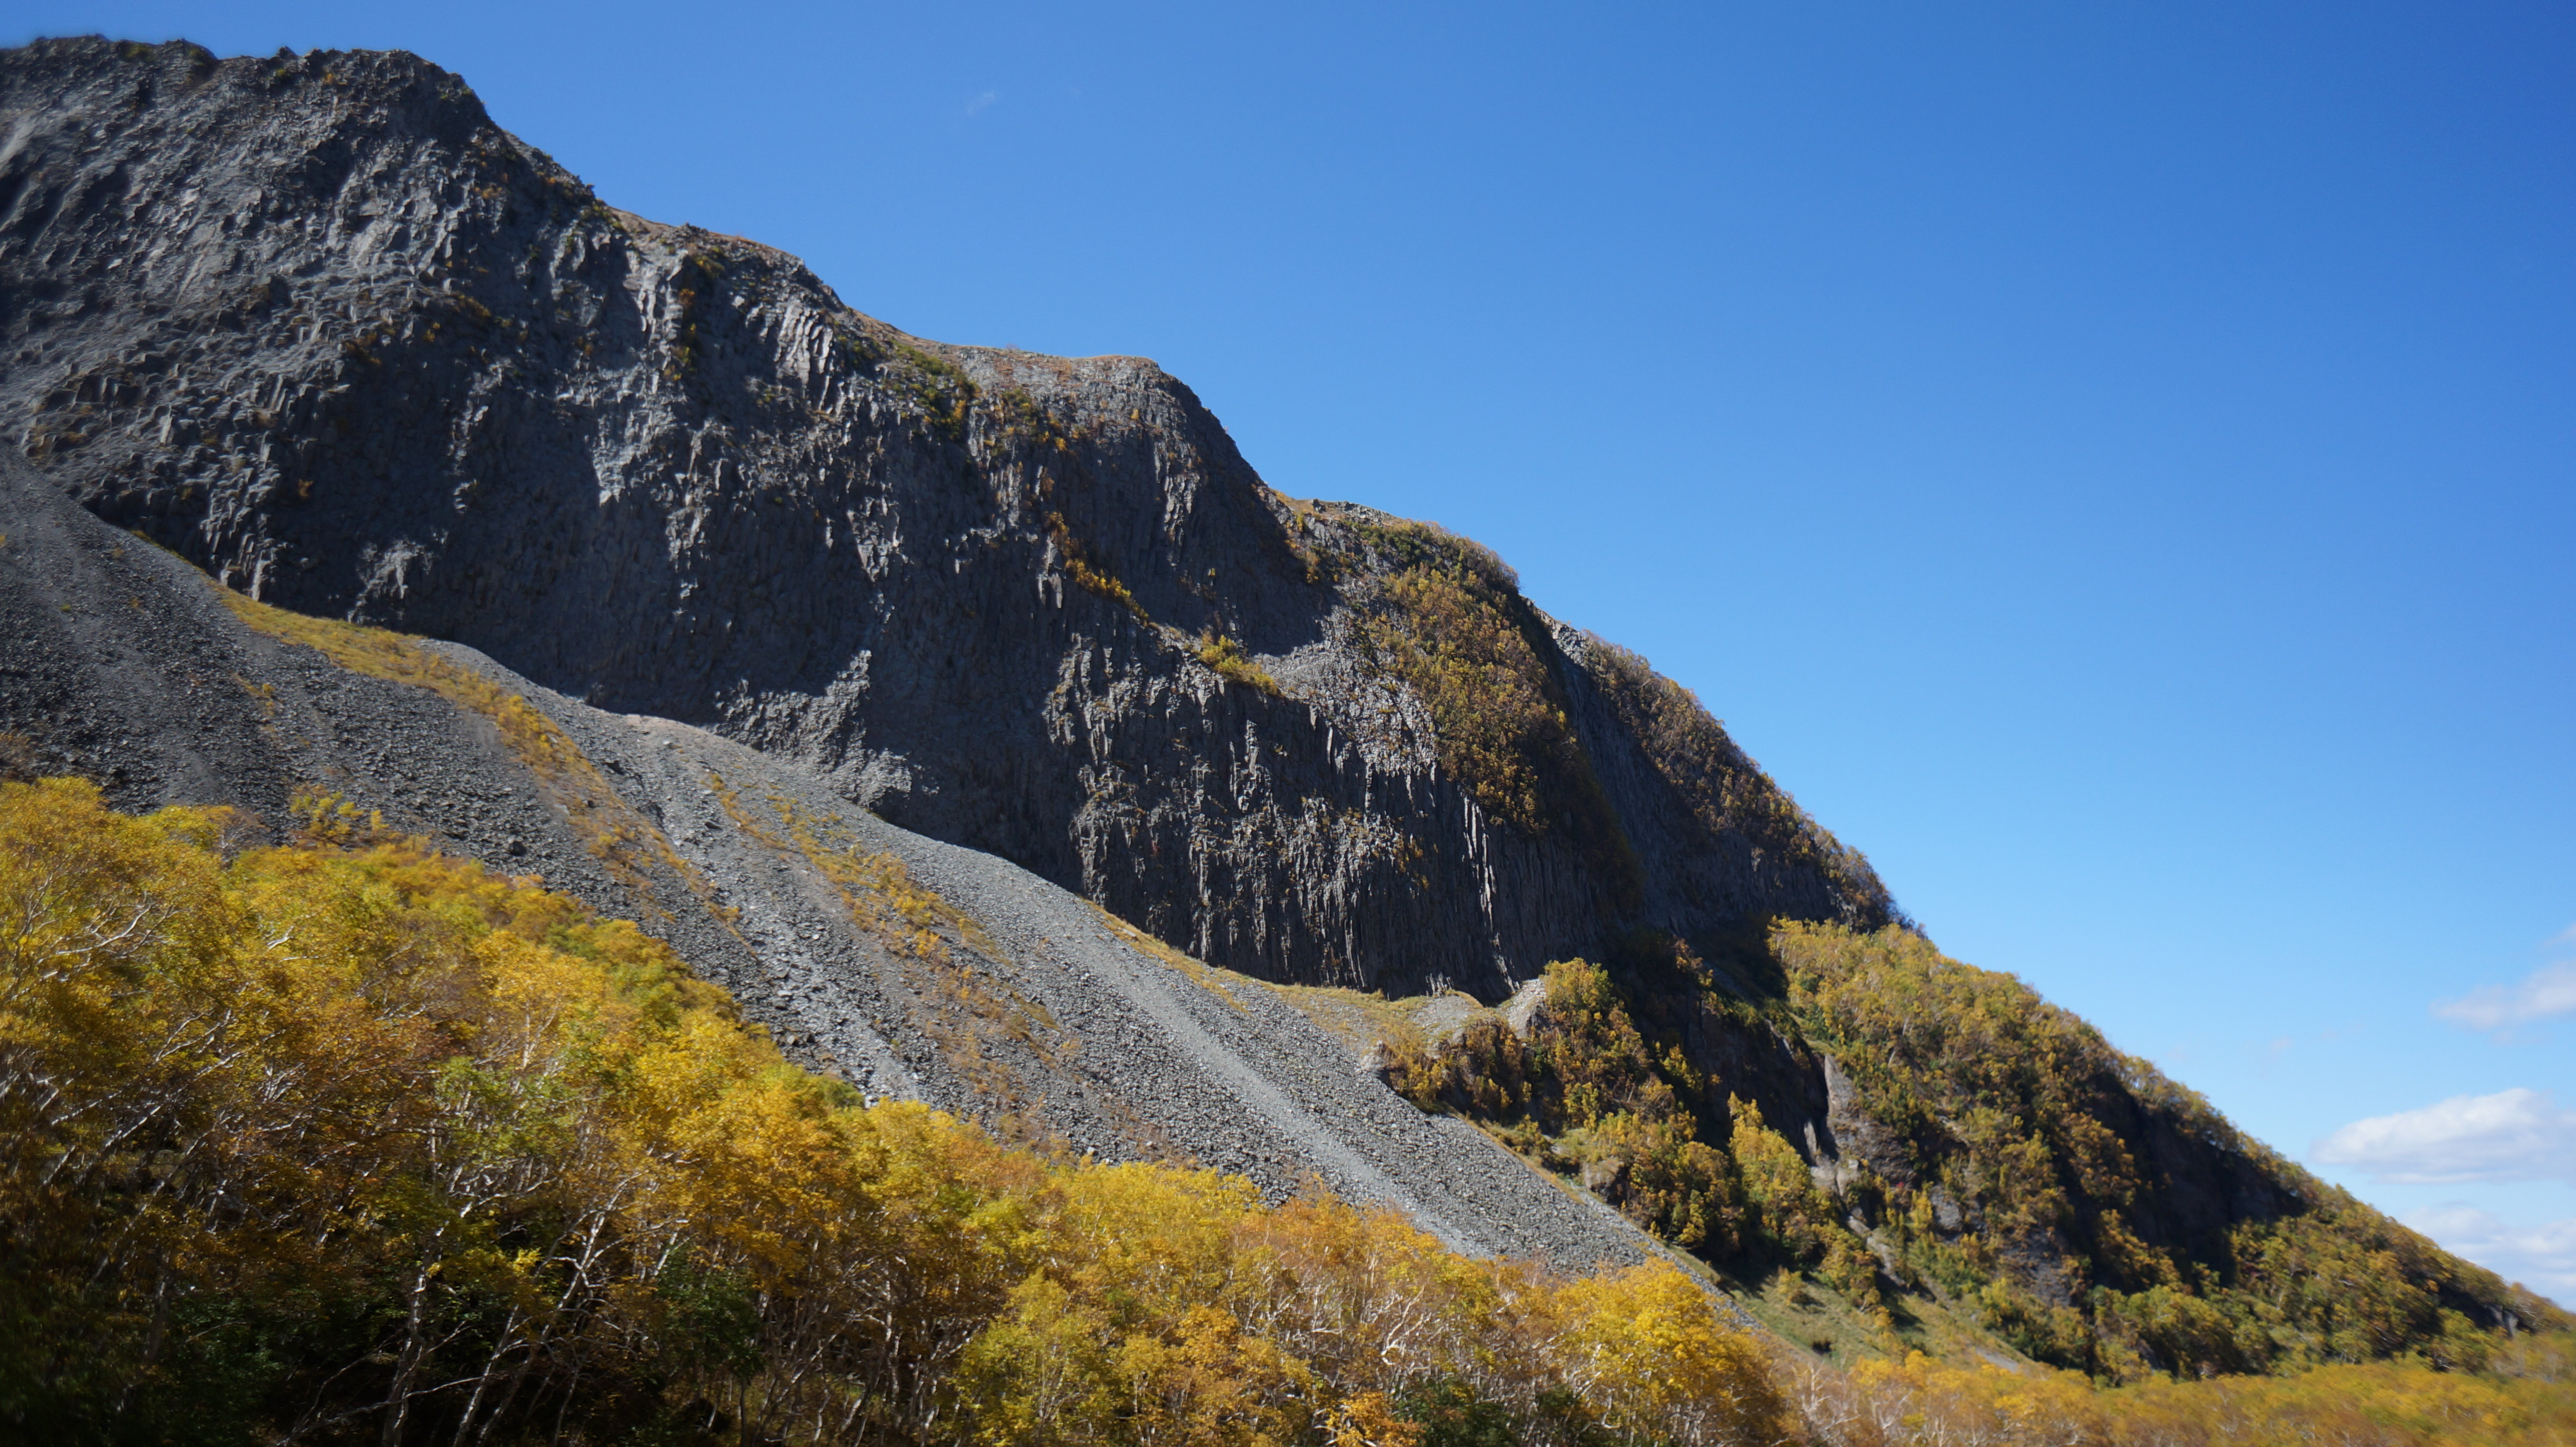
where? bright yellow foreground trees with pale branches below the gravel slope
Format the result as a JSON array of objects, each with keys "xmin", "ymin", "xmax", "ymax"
[{"xmin": 0, "ymin": 780, "xmax": 1759, "ymax": 1447}]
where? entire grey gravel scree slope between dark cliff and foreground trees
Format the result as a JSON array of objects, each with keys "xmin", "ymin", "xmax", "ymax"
[{"xmin": 0, "ymin": 453, "xmax": 1651, "ymax": 1267}]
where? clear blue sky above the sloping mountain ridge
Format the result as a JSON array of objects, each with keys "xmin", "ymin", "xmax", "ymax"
[{"xmin": 25, "ymin": 0, "xmax": 2576, "ymax": 1300}]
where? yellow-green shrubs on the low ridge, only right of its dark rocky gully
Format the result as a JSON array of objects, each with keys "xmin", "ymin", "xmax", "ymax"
[{"xmin": 1770, "ymin": 922, "xmax": 2556, "ymax": 1377}]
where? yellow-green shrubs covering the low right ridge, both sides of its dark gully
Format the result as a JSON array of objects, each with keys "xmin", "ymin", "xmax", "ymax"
[{"xmin": 1391, "ymin": 922, "xmax": 2566, "ymax": 1380}]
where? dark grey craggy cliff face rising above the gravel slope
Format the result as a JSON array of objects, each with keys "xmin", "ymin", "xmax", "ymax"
[{"xmin": 0, "ymin": 41, "xmax": 1893, "ymax": 999}]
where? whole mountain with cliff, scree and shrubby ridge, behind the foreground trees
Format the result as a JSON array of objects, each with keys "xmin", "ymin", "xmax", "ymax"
[{"xmin": 0, "ymin": 25, "xmax": 2558, "ymax": 1377}]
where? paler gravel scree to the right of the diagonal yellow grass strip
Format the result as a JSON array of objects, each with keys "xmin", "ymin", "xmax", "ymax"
[{"xmin": 468, "ymin": 664, "xmax": 1638, "ymax": 1264}]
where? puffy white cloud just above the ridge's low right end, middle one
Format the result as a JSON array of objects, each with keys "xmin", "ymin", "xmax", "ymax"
[{"xmin": 2308, "ymin": 1086, "xmax": 2576, "ymax": 1184}]
